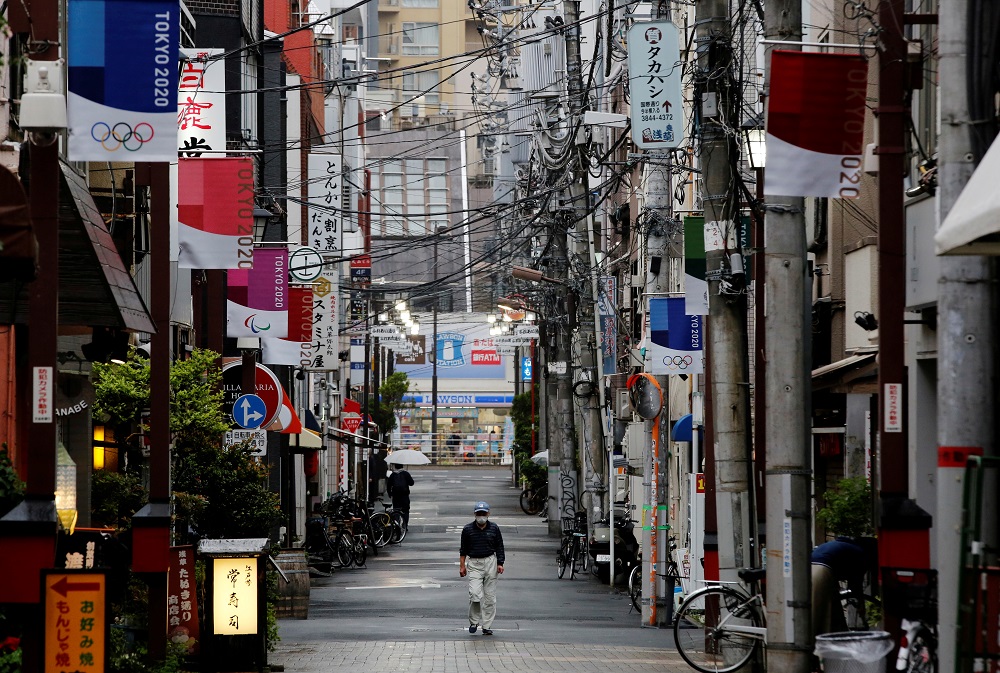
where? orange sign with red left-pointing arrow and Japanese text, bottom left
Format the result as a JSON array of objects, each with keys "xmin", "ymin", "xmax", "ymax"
[{"xmin": 42, "ymin": 571, "xmax": 109, "ymax": 673}]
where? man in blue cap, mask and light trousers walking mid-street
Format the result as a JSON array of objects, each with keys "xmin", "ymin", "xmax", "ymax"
[{"xmin": 458, "ymin": 501, "xmax": 504, "ymax": 636}]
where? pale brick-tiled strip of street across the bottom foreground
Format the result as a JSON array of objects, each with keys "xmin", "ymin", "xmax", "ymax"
[{"xmin": 268, "ymin": 629, "xmax": 692, "ymax": 673}]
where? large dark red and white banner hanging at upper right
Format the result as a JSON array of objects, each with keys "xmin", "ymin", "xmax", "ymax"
[{"xmin": 764, "ymin": 50, "xmax": 868, "ymax": 199}]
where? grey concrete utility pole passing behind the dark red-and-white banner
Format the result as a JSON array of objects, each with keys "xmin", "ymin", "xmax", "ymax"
[{"xmin": 760, "ymin": 0, "xmax": 812, "ymax": 673}]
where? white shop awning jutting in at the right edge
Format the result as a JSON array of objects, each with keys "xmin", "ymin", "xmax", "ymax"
[{"xmin": 934, "ymin": 135, "xmax": 1000, "ymax": 255}]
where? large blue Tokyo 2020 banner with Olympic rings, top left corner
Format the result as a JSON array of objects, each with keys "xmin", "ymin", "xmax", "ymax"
[{"xmin": 68, "ymin": 0, "xmax": 180, "ymax": 161}]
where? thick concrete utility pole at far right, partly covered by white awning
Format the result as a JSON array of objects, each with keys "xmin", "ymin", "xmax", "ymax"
[{"xmin": 934, "ymin": 0, "xmax": 997, "ymax": 673}]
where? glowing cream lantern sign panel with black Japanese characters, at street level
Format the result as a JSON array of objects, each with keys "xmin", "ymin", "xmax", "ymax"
[{"xmin": 212, "ymin": 556, "xmax": 258, "ymax": 636}]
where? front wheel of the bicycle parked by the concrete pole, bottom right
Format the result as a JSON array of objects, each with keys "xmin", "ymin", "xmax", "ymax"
[{"xmin": 674, "ymin": 587, "xmax": 764, "ymax": 673}]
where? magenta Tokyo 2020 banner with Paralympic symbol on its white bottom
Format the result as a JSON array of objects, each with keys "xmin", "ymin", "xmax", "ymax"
[{"xmin": 226, "ymin": 248, "xmax": 289, "ymax": 339}]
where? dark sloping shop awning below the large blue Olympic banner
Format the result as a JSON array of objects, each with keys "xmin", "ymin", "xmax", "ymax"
[{"xmin": 0, "ymin": 163, "xmax": 156, "ymax": 332}]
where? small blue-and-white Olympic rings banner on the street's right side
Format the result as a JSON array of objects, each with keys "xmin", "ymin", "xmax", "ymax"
[{"xmin": 645, "ymin": 297, "xmax": 705, "ymax": 374}]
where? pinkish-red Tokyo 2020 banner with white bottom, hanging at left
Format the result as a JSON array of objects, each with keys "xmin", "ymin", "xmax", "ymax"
[{"xmin": 177, "ymin": 158, "xmax": 254, "ymax": 269}]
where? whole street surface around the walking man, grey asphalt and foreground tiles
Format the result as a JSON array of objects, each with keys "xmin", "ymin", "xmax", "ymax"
[{"xmin": 269, "ymin": 466, "xmax": 692, "ymax": 673}]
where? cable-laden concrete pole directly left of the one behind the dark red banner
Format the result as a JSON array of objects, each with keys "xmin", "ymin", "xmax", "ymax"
[{"xmin": 695, "ymin": 0, "xmax": 753, "ymax": 581}]
